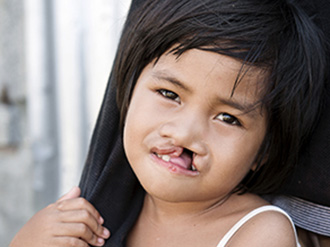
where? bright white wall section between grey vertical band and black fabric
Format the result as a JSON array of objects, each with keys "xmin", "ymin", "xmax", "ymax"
[{"xmin": 54, "ymin": 0, "xmax": 129, "ymax": 193}]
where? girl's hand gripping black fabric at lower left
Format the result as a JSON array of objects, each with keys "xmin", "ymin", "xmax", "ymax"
[{"xmin": 10, "ymin": 187, "xmax": 110, "ymax": 247}]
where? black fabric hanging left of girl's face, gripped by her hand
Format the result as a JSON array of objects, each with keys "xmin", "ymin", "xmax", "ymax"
[{"xmin": 79, "ymin": 0, "xmax": 144, "ymax": 247}]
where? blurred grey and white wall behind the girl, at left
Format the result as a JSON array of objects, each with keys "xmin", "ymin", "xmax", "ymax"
[{"xmin": 0, "ymin": 0, "xmax": 130, "ymax": 246}]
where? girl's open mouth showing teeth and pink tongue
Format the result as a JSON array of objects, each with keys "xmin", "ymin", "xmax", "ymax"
[{"xmin": 153, "ymin": 148, "xmax": 198, "ymax": 173}]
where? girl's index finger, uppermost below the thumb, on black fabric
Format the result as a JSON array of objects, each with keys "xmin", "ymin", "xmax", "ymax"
[{"xmin": 57, "ymin": 197, "xmax": 104, "ymax": 225}]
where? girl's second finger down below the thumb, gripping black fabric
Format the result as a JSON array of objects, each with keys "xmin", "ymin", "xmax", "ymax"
[{"xmin": 60, "ymin": 209, "xmax": 110, "ymax": 238}]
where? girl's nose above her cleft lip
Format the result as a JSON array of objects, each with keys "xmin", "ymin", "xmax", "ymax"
[{"xmin": 159, "ymin": 111, "xmax": 207, "ymax": 155}]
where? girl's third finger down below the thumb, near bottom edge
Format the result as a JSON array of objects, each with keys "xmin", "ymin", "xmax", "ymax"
[{"xmin": 55, "ymin": 223, "xmax": 104, "ymax": 246}]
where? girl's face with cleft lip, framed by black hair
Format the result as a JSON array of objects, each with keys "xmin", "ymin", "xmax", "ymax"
[{"xmin": 124, "ymin": 49, "xmax": 266, "ymax": 205}]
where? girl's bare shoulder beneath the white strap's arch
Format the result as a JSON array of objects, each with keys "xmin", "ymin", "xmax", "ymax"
[{"xmin": 230, "ymin": 207, "xmax": 296, "ymax": 247}]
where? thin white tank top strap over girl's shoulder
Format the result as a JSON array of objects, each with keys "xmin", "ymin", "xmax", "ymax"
[{"xmin": 217, "ymin": 205, "xmax": 300, "ymax": 247}]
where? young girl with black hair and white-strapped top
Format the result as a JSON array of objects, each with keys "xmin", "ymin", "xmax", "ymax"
[{"xmin": 11, "ymin": 0, "xmax": 325, "ymax": 247}]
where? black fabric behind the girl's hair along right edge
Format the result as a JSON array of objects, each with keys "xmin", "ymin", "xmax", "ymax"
[{"xmin": 283, "ymin": 0, "xmax": 330, "ymax": 207}]
